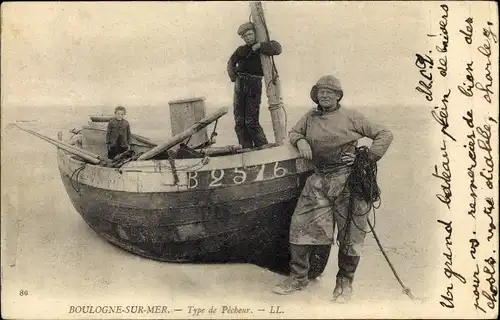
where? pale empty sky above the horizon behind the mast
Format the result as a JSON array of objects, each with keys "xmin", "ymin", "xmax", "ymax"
[{"xmin": 1, "ymin": 2, "xmax": 429, "ymax": 107}]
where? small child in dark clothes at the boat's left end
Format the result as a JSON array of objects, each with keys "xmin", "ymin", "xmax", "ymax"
[{"xmin": 106, "ymin": 106, "xmax": 132, "ymax": 159}]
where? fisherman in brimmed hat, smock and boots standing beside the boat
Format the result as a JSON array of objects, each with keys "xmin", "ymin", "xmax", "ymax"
[{"xmin": 273, "ymin": 75, "xmax": 393, "ymax": 302}]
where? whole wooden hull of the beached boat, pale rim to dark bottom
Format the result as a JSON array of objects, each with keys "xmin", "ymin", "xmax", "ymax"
[{"xmin": 58, "ymin": 142, "xmax": 330, "ymax": 274}]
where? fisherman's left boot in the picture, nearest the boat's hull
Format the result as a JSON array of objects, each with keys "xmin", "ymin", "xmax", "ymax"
[{"xmin": 273, "ymin": 244, "xmax": 312, "ymax": 295}]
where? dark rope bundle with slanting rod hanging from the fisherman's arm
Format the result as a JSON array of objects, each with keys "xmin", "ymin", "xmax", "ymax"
[{"xmin": 344, "ymin": 146, "xmax": 415, "ymax": 300}]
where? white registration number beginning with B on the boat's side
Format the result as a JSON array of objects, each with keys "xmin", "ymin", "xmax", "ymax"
[{"xmin": 187, "ymin": 160, "xmax": 297, "ymax": 189}]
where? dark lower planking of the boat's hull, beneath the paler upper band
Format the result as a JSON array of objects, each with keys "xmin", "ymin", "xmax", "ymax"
[{"xmin": 62, "ymin": 175, "xmax": 294, "ymax": 268}]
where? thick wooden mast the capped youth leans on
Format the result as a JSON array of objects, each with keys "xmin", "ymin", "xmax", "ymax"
[{"xmin": 250, "ymin": 1, "xmax": 285, "ymax": 145}]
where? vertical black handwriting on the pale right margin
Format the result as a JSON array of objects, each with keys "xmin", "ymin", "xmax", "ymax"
[{"xmin": 415, "ymin": 3, "xmax": 498, "ymax": 315}]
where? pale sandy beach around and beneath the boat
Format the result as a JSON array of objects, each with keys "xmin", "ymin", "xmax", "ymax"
[{"xmin": 2, "ymin": 107, "xmax": 435, "ymax": 318}]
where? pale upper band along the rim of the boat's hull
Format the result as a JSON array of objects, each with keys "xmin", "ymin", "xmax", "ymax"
[{"xmin": 57, "ymin": 145, "xmax": 312, "ymax": 193}]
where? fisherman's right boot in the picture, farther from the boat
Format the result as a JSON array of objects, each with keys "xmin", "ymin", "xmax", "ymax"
[{"xmin": 332, "ymin": 250, "xmax": 360, "ymax": 303}]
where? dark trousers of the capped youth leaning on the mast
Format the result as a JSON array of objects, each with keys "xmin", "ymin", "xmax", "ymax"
[{"xmin": 233, "ymin": 76, "xmax": 267, "ymax": 148}]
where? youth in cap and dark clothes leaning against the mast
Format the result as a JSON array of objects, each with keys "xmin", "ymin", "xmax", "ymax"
[{"xmin": 227, "ymin": 22, "xmax": 281, "ymax": 148}]
